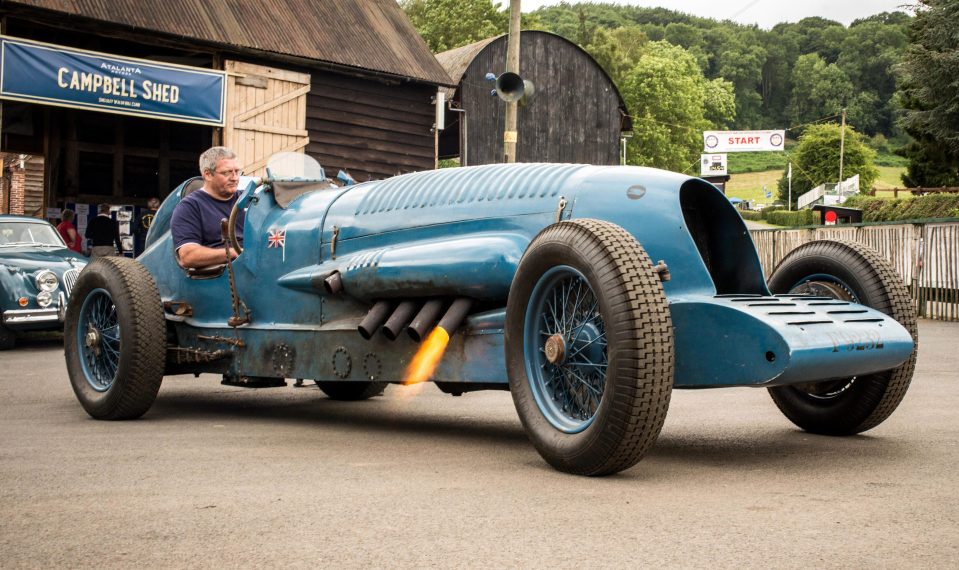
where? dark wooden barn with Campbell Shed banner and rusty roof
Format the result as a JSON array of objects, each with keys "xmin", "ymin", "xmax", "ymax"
[{"xmin": 0, "ymin": 0, "xmax": 452, "ymax": 217}]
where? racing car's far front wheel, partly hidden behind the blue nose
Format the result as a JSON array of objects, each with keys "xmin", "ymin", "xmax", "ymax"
[{"xmin": 769, "ymin": 237, "xmax": 919, "ymax": 435}]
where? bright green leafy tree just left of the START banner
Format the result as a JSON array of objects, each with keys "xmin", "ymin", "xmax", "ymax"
[{"xmin": 620, "ymin": 42, "xmax": 735, "ymax": 172}]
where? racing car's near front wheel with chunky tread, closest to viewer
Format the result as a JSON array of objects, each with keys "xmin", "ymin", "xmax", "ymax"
[{"xmin": 505, "ymin": 219, "xmax": 674, "ymax": 475}]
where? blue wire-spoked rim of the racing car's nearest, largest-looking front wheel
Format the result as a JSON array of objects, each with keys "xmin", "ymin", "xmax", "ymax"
[{"xmin": 523, "ymin": 265, "xmax": 609, "ymax": 433}]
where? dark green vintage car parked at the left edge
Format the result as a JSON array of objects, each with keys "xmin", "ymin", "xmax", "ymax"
[{"xmin": 0, "ymin": 215, "xmax": 87, "ymax": 350}]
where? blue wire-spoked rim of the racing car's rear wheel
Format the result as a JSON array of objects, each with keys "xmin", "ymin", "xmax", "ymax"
[{"xmin": 77, "ymin": 289, "xmax": 120, "ymax": 392}]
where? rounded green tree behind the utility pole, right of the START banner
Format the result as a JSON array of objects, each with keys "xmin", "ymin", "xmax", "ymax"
[{"xmin": 779, "ymin": 123, "xmax": 879, "ymax": 208}]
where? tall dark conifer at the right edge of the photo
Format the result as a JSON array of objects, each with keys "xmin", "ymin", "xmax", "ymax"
[{"xmin": 897, "ymin": 0, "xmax": 959, "ymax": 186}]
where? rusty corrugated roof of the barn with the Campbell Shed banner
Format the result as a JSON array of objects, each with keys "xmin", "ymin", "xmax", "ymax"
[{"xmin": 4, "ymin": 0, "xmax": 451, "ymax": 85}]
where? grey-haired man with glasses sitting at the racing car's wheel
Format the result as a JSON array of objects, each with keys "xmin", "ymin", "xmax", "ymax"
[{"xmin": 170, "ymin": 146, "xmax": 243, "ymax": 267}]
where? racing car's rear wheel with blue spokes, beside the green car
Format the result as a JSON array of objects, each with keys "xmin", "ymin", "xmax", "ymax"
[{"xmin": 63, "ymin": 257, "xmax": 166, "ymax": 420}]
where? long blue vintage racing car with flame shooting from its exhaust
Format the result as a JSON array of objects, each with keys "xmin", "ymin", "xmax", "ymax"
[{"xmin": 65, "ymin": 155, "xmax": 917, "ymax": 475}]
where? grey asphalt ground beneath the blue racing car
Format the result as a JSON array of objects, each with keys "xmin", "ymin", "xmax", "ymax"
[{"xmin": 0, "ymin": 321, "xmax": 959, "ymax": 569}]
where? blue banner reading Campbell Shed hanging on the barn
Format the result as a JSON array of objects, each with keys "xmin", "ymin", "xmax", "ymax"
[{"xmin": 0, "ymin": 36, "xmax": 226, "ymax": 127}]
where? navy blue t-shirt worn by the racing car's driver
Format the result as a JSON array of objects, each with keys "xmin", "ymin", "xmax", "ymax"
[{"xmin": 170, "ymin": 189, "xmax": 244, "ymax": 250}]
